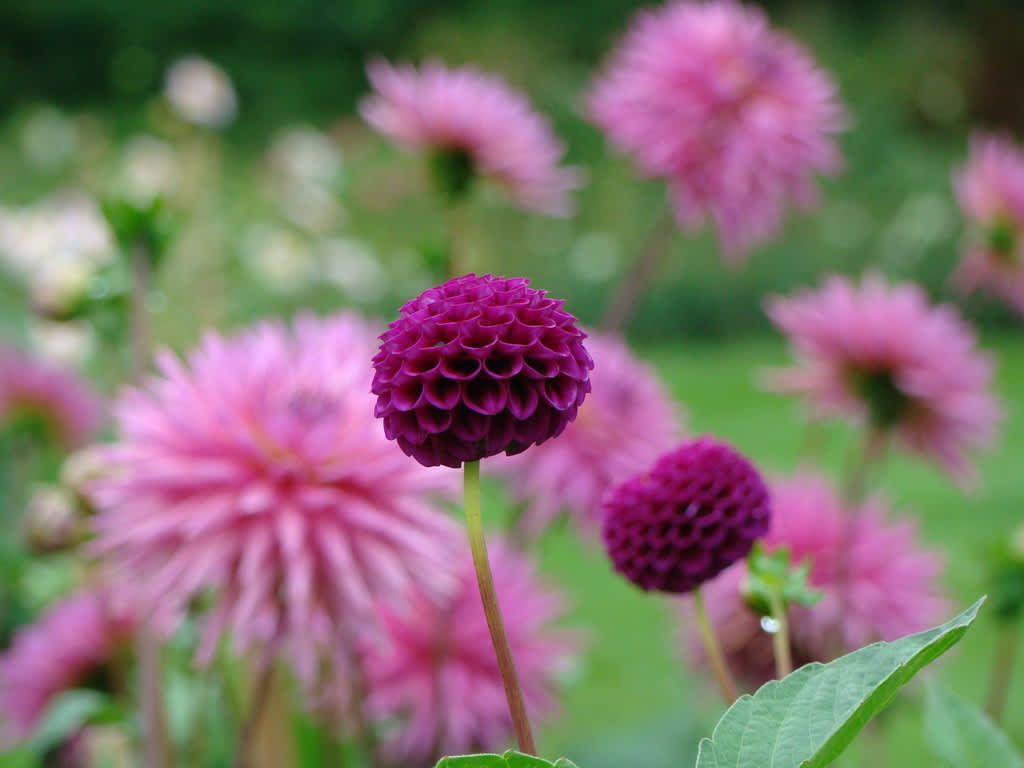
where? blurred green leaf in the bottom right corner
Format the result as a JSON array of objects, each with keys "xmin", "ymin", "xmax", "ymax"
[{"xmin": 925, "ymin": 684, "xmax": 1024, "ymax": 768}]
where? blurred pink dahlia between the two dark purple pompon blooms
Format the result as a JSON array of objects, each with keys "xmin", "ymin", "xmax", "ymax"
[{"xmin": 494, "ymin": 334, "xmax": 682, "ymax": 537}]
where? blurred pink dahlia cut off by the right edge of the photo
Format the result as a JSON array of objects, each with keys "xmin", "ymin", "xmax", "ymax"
[{"xmin": 953, "ymin": 134, "xmax": 1024, "ymax": 314}]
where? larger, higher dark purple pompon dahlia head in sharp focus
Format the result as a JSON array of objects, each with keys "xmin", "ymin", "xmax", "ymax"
[{"xmin": 373, "ymin": 274, "xmax": 594, "ymax": 467}]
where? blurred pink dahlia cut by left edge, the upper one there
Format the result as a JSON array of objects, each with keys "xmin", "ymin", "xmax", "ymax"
[{"xmin": 0, "ymin": 345, "xmax": 103, "ymax": 451}]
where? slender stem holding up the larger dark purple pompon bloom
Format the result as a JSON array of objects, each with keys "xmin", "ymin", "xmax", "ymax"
[{"xmin": 463, "ymin": 462, "xmax": 537, "ymax": 755}]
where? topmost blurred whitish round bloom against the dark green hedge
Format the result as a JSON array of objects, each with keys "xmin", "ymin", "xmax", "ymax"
[{"xmin": 164, "ymin": 55, "xmax": 238, "ymax": 128}]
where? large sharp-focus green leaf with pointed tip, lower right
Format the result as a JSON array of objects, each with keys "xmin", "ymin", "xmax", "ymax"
[{"xmin": 696, "ymin": 598, "xmax": 984, "ymax": 768}]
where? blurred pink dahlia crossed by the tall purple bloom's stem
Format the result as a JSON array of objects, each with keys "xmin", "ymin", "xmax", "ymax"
[{"xmin": 364, "ymin": 541, "xmax": 578, "ymax": 765}]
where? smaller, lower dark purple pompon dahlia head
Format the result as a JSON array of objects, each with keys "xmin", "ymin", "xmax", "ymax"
[{"xmin": 602, "ymin": 437, "xmax": 771, "ymax": 593}]
